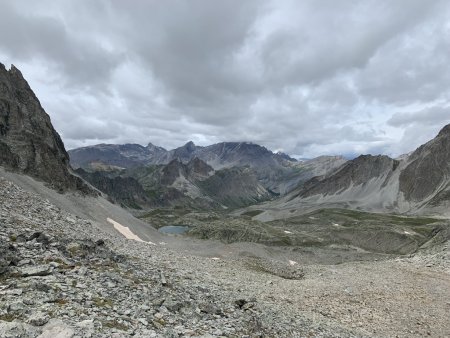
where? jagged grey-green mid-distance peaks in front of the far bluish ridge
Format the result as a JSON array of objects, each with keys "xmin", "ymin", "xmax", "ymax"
[{"xmin": 123, "ymin": 157, "xmax": 271, "ymax": 209}]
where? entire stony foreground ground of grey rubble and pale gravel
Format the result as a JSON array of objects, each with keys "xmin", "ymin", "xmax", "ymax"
[{"xmin": 0, "ymin": 178, "xmax": 450, "ymax": 337}]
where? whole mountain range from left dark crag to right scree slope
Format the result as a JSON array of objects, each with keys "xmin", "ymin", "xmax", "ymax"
[{"xmin": 0, "ymin": 64, "xmax": 450, "ymax": 219}]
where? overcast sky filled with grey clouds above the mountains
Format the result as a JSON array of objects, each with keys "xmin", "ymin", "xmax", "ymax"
[{"xmin": 0, "ymin": 0, "xmax": 450, "ymax": 157}]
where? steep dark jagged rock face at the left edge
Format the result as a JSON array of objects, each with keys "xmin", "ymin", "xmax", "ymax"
[{"xmin": 0, "ymin": 63, "xmax": 89, "ymax": 191}]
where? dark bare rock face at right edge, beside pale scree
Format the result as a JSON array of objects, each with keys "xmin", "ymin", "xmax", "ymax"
[{"xmin": 400, "ymin": 124, "xmax": 450, "ymax": 202}]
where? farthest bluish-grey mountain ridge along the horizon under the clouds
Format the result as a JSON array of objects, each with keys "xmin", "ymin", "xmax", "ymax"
[{"xmin": 69, "ymin": 141, "xmax": 346, "ymax": 195}]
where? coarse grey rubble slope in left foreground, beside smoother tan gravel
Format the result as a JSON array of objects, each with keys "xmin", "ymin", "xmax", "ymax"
[{"xmin": 0, "ymin": 179, "xmax": 356, "ymax": 337}]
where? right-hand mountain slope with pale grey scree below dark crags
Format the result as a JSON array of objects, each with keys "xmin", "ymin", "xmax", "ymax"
[{"xmin": 253, "ymin": 125, "xmax": 450, "ymax": 220}]
